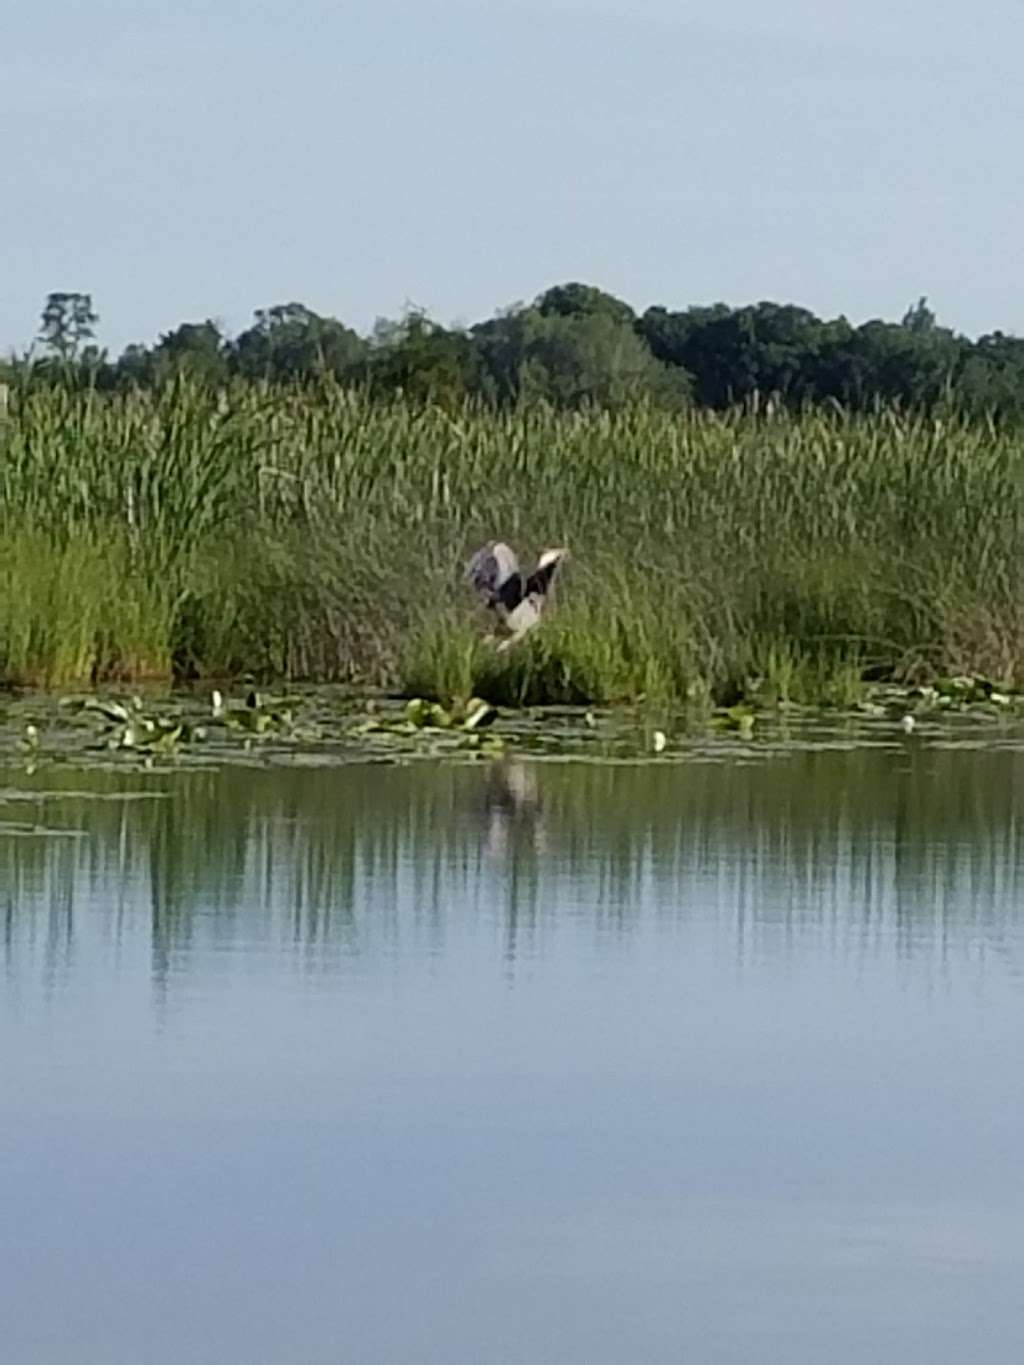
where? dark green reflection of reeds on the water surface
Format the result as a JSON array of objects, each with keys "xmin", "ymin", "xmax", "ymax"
[{"xmin": 0, "ymin": 747, "xmax": 1024, "ymax": 1010}]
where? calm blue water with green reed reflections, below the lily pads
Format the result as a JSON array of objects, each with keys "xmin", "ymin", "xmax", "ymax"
[{"xmin": 0, "ymin": 737, "xmax": 1024, "ymax": 1365}]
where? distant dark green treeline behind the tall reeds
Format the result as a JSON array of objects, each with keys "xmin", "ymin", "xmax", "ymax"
[{"xmin": 8, "ymin": 283, "xmax": 1024, "ymax": 418}]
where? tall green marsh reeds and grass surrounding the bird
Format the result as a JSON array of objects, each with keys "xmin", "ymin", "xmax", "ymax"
[{"xmin": 0, "ymin": 379, "xmax": 1024, "ymax": 703}]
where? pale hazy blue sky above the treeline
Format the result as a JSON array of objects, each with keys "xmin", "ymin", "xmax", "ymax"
[{"xmin": 8, "ymin": 0, "xmax": 1024, "ymax": 349}]
